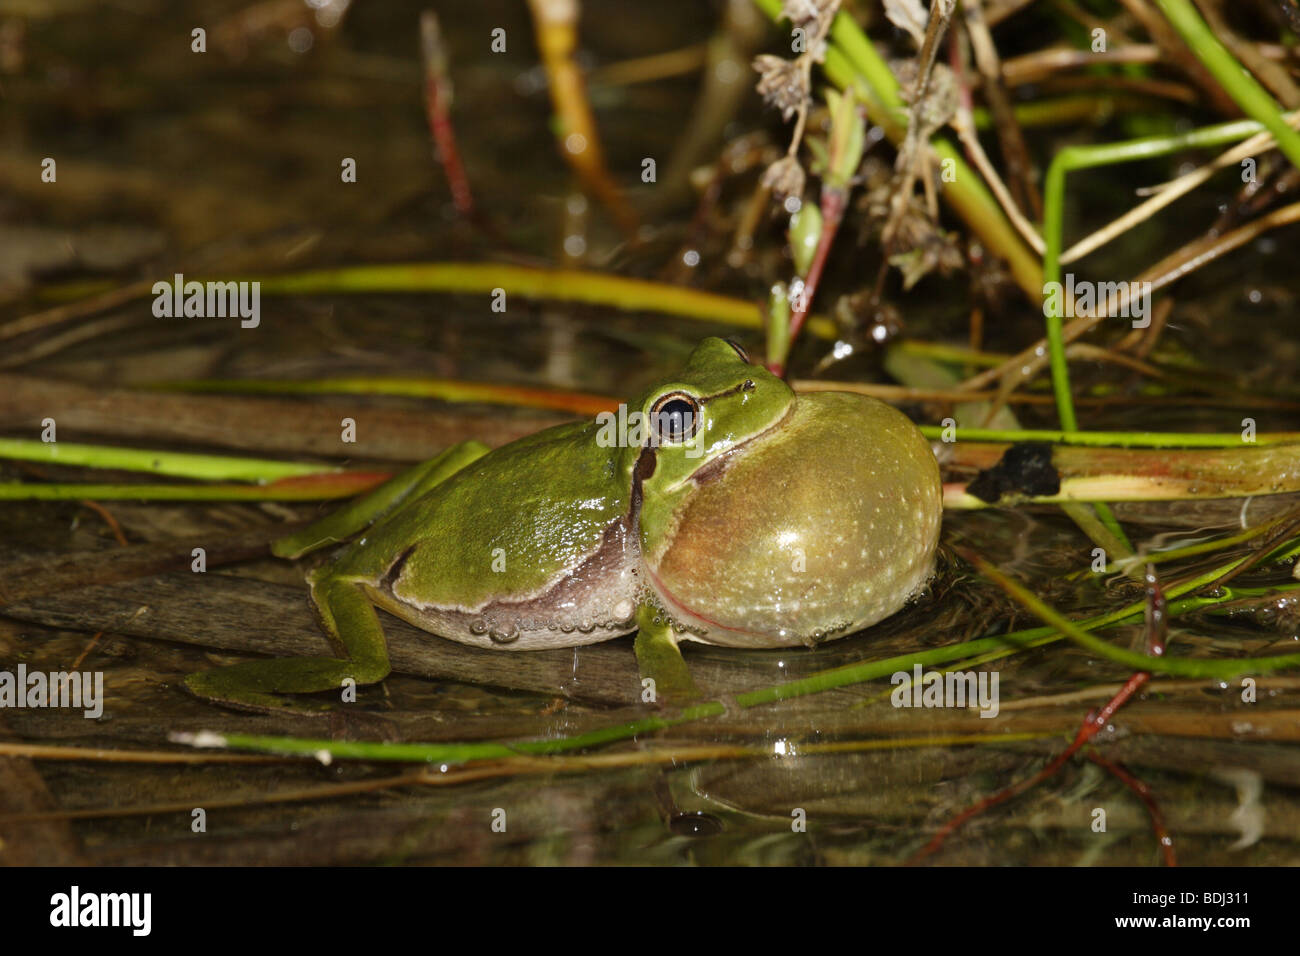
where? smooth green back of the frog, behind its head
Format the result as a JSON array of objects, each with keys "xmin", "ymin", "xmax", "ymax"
[{"xmin": 334, "ymin": 423, "xmax": 629, "ymax": 609}]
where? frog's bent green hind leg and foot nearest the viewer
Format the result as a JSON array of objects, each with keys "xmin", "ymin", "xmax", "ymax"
[{"xmin": 185, "ymin": 574, "xmax": 390, "ymax": 715}]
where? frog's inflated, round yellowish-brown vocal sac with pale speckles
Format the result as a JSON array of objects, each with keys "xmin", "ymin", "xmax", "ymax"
[{"xmin": 644, "ymin": 392, "xmax": 943, "ymax": 648}]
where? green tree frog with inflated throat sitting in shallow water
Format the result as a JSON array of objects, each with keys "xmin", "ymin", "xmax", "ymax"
[{"xmin": 185, "ymin": 337, "xmax": 943, "ymax": 710}]
